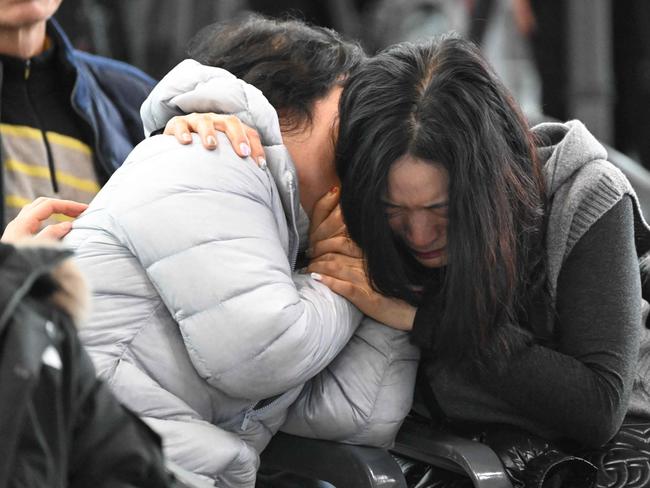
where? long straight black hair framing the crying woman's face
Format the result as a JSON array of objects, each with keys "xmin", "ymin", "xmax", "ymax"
[{"xmin": 337, "ymin": 36, "xmax": 545, "ymax": 364}]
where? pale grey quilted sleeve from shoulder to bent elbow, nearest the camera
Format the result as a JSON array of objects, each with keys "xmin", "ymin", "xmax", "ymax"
[{"xmin": 109, "ymin": 136, "xmax": 360, "ymax": 399}]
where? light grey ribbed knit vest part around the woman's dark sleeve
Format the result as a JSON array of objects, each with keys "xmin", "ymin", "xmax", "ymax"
[{"xmin": 533, "ymin": 120, "xmax": 650, "ymax": 417}]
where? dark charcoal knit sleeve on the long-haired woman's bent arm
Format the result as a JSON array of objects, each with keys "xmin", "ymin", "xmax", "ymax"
[{"xmin": 483, "ymin": 198, "xmax": 641, "ymax": 446}]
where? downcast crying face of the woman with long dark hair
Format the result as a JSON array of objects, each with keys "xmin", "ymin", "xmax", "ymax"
[{"xmin": 384, "ymin": 154, "xmax": 449, "ymax": 268}]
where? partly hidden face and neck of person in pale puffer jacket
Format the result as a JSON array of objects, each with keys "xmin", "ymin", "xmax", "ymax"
[{"xmin": 283, "ymin": 86, "xmax": 342, "ymax": 218}]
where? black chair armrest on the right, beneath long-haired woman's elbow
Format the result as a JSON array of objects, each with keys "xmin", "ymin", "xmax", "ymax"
[{"xmin": 391, "ymin": 418, "xmax": 512, "ymax": 488}]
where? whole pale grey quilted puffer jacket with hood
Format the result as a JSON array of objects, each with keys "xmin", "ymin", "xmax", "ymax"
[{"xmin": 66, "ymin": 60, "xmax": 418, "ymax": 487}]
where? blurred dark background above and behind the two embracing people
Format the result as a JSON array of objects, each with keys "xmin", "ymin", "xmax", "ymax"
[{"xmin": 56, "ymin": 0, "xmax": 650, "ymax": 173}]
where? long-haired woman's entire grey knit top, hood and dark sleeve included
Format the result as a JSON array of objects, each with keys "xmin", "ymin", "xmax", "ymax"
[{"xmin": 416, "ymin": 121, "xmax": 650, "ymax": 445}]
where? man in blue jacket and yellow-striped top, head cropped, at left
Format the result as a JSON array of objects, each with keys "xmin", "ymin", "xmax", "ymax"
[{"xmin": 0, "ymin": 0, "xmax": 154, "ymax": 238}]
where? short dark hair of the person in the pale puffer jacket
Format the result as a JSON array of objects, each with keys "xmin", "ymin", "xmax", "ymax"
[{"xmin": 188, "ymin": 14, "xmax": 365, "ymax": 130}]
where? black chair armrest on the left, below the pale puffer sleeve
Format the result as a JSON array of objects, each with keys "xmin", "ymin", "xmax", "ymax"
[{"xmin": 261, "ymin": 432, "xmax": 406, "ymax": 488}]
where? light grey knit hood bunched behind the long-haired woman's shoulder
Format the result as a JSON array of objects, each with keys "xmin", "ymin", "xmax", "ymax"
[{"xmin": 532, "ymin": 120, "xmax": 607, "ymax": 196}]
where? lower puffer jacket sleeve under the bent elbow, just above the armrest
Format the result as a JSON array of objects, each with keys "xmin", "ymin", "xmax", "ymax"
[{"xmin": 282, "ymin": 317, "xmax": 419, "ymax": 447}]
